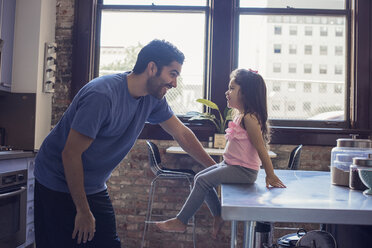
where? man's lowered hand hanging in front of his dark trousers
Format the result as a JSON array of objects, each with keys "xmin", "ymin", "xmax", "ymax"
[{"xmin": 72, "ymin": 211, "xmax": 96, "ymax": 244}]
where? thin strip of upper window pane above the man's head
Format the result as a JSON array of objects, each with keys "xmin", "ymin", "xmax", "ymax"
[{"xmin": 103, "ymin": 0, "xmax": 207, "ymax": 6}]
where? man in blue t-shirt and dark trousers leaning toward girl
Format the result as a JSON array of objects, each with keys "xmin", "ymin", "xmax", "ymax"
[{"xmin": 35, "ymin": 40, "xmax": 215, "ymax": 248}]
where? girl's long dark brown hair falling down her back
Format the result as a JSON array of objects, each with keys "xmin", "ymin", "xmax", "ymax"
[{"xmin": 230, "ymin": 69, "xmax": 270, "ymax": 145}]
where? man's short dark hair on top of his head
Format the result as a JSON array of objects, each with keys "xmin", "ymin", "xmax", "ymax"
[{"xmin": 133, "ymin": 40, "xmax": 185, "ymax": 75}]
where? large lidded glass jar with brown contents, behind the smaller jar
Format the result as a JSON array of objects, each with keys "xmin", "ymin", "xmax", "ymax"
[{"xmin": 331, "ymin": 137, "xmax": 372, "ymax": 186}]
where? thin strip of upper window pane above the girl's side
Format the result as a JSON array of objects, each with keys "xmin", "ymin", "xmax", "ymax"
[{"xmin": 240, "ymin": 0, "xmax": 345, "ymax": 9}]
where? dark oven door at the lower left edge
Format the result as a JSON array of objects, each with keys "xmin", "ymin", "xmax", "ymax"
[{"xmin": 0, "ymin": 186, "xmax": 27, "ymax": 248}]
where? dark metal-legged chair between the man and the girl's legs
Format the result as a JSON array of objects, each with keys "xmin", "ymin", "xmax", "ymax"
[{"xmin": 141, "ymin": 140, "xmax": 196, "ymax": 248}]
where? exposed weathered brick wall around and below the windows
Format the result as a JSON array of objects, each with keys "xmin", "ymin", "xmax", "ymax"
[{"xmin": 52, "ymin": 0, "xmax": 331, "ymax": 248}]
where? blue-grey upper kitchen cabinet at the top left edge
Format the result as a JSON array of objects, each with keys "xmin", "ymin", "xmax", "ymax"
[{"xmin": 0, "ymin": 0, "xmax": 16, "ymax": 92}]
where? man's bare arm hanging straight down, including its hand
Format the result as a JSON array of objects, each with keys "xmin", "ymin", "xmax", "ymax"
[{"xmin": 62, "ymin": 129, "xmax": 95, "ymax": 244}]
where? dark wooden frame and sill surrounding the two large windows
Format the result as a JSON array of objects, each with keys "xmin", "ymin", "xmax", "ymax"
[{"xmin": 71, "ymin": 0, "xmax": 372, "ymax": 145}]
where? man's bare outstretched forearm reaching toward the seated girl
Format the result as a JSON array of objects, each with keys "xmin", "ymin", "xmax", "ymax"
[{"xmin": 160, "ymin": 115, "xmax": 216, "ymax": 167}]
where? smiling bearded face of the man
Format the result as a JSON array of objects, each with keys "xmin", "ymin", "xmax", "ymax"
[{"xmin": 147, "ymin": 61, "xmax": 182, "ymax": 99}]
